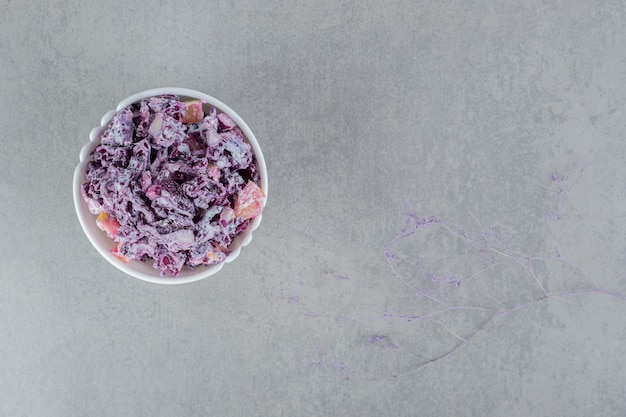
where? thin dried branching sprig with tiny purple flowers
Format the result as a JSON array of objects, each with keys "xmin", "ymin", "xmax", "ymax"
[{"xmin": 279, "ymin": 167, "xmax": 626, "ymax": 380}]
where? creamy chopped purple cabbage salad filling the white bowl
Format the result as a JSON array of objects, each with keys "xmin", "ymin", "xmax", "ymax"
[{"xmin": 81, "ymin": 95, "xmax": 265, "ymax": 277}]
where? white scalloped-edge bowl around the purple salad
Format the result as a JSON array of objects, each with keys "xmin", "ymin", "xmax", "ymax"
[{"xmin": 74, "ymin": 87, "xmax": 267, "ymax": 284}]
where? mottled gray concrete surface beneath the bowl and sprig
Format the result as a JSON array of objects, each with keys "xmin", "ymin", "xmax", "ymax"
[{"xmin": 0, "ymin": 0, "xmax": 626, "ymax": 417}]
